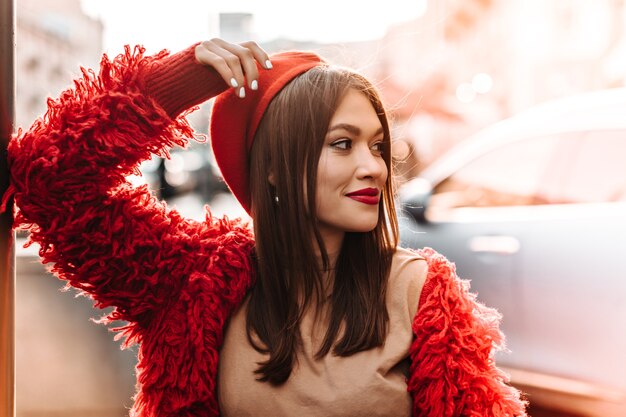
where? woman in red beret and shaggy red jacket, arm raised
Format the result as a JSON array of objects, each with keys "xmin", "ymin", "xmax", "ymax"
[{"xmin": 5, "ymin": 39, "xmax": 525, "ymax": 417}]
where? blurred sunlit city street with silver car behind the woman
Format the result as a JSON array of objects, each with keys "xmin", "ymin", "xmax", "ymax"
[{"xmin": 0, "ymin": 0, "xmax": 626, "ymax": 417}]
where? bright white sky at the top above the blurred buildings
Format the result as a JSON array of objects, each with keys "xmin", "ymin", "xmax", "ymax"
[{"xmin": 82, "ymin": 0, "xmax": 432, "ymax": 52}]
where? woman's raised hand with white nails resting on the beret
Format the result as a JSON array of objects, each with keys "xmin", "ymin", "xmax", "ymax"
[{"xmin": 195, "ymin": 39, "xmax": 272, "ymax": 98}]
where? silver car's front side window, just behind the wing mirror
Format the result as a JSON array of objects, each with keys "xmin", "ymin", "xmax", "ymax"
[{"xmin": 429, "ymin": 135, "xmax": 564, "ymax": 213}]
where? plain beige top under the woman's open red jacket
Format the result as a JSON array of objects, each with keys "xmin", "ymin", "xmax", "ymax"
[{"xmin": 218, "ymin": 249, "xmax": 427, "ymax": 417}]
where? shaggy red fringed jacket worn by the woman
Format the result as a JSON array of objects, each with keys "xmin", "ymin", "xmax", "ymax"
[{"xmin": 8, "ymin": 44, "xmax": 525, "ymax": 417}]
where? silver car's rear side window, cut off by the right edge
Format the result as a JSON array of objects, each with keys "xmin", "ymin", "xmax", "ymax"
[{"xmin": 549, "ymin": 130, "xmax": 626, "ymax": 203}]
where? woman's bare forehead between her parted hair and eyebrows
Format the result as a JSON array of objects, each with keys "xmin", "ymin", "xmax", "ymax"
[{"xmin": 330, "ymin": 88, "xmax": 381, "ymax": 130}]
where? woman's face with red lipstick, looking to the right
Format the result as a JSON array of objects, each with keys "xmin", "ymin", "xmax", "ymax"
[{"xmin": 316, "ymin": 89, "xmax": 388, "ymax": 242}]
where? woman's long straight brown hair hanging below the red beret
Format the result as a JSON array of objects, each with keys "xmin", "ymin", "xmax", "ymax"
[{"xmin": 246, "ymin": 66, "xmax": 398, "ymax": 385}]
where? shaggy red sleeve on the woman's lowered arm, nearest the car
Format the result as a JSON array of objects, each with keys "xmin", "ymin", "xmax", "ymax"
[{"xmin": 408, "ymin": 248, "xmax": 526, "ymax": 417}]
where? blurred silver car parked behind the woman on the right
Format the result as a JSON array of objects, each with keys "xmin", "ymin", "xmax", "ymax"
[{"xmin": 399, "ymin": 89, "xmax": 626, "ymax": 417}]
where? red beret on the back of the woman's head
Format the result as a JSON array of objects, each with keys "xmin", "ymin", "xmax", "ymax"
[{"xmin": 211, "ymin": 52, "xmax": 324, "ymax": 213}]
